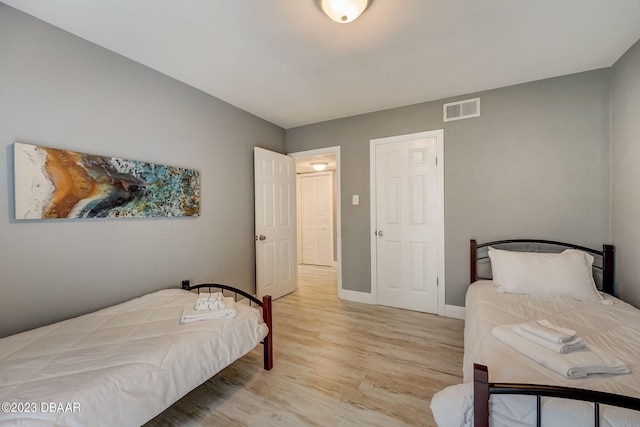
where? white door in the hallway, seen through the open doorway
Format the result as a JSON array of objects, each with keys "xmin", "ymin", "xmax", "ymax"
[{"xmin": 299, "ymin": 172, "xmax": 333, "ymax": 266}]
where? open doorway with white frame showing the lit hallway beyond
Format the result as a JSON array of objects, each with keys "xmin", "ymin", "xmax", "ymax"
[{"xmin": 289, "ymin": 147, "xmax": 342, "ymax": 295}]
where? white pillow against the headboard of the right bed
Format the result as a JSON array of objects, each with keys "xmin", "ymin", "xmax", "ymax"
[{"xmin": 489, "ymin": 248, "xmax": 603, "ymax": 302}]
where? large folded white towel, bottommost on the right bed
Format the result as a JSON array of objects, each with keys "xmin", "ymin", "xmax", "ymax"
[{"xmin": 491, "ymin": 325, "xmax": 629, "ymax": 378}]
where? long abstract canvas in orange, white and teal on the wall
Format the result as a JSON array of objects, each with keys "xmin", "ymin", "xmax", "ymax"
[{"xmin": 14, "ymin": 142, "xmax": 200, "ymax": 219}]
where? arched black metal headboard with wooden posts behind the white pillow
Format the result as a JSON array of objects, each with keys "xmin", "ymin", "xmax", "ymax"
[{"xmin": 469, "ymin": 239, "xmax": 615, "ymax": 295}]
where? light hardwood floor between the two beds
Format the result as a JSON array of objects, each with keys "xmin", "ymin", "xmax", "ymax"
[{"xmin": 146, "ymin": 266, "xmax": 464, "ymax": 427}]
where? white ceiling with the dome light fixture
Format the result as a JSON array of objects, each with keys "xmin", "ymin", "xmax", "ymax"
[{"xmin": 2, "ymin": 0, "xmax": 640, "ymax": 129}]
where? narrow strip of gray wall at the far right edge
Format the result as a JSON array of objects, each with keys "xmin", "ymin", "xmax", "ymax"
[{"xmin": 611, "ymin": 42, "xmax": 640, "ymax": 308}]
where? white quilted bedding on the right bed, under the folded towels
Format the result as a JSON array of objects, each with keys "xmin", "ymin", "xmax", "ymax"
[{"xmin": 432, "ymin": 281, "xmax": 640, "ymax": 426}]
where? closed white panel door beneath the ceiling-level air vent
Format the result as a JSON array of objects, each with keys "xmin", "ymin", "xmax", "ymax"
[{"xmin": 373, "ymin": 136, "xmax": 441, "ymax": 313}]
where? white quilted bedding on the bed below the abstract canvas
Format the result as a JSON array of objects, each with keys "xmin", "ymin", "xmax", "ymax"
[{"xmin": 0, "ymin": 289, "xmax": 268, "ymax": 427}]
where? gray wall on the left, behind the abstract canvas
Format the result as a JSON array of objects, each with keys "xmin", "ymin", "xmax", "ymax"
[{"xmin": 0, "ymin": 3, "xmax": 284, "ymax": 336}]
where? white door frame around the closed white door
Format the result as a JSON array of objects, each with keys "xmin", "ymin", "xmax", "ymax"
[{"xmin": 369, "ymin": 129, "xmax": 445, "ymax": 316}]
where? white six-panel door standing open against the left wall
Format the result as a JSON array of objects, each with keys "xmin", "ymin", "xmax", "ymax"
[{"xmin": 254, "ymin": 147, "xmax": 297, "ymax": 299}]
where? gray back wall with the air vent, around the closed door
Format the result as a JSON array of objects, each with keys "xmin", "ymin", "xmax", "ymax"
[{"xmin": 286, "ymin": 69, "xmax": 610, "ymax": 306}]
